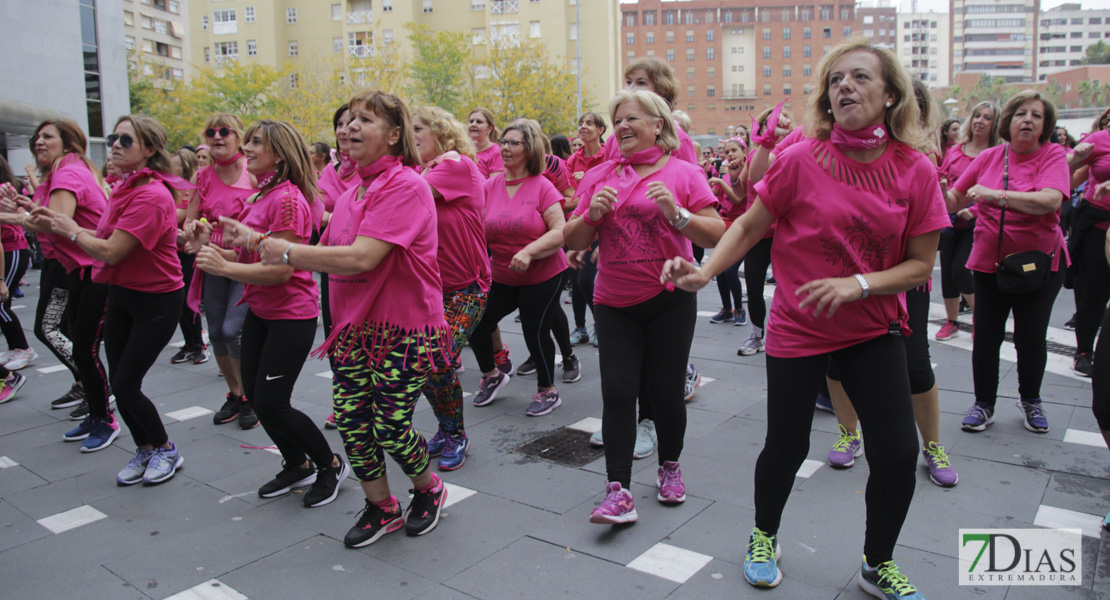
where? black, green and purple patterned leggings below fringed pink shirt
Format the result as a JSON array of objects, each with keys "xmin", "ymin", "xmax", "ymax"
[{"xmin": 332, "ymin": 336, "xmax": 432, "ymax": 481}]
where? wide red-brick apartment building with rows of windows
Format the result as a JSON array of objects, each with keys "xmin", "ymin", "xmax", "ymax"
[{"xmin": 620, "ymin": 0, "xmax": 897, "ymax": 135}]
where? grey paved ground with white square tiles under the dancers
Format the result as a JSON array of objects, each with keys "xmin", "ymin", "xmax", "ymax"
[{"xmin": 0, "ymin": 265, "xmax": 1110, "ymax": 600}]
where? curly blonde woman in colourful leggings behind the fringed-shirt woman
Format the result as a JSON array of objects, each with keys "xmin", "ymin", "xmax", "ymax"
[{"xmin": 413, "ymin": 106, "xmax": 491, "ymax": 471}]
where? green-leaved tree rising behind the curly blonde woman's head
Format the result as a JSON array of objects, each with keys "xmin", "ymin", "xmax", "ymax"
[{"xmin": 405, "ymin": 23, "xmax": 474, "ymax": 113}]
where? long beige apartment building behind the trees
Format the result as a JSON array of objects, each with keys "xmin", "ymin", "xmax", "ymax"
[{"xmin": 190, "ymin": 0, "xmax": 620, "ymax": 106}]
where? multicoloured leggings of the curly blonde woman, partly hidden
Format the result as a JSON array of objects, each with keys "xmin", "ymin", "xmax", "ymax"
[{"xmin": 424, "ymin": 283, "xmax": 486, "ymax": 437}]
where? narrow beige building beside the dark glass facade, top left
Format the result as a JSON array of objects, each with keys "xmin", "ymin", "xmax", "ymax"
[{"xmin": 123, "ymin": 0, "xmax": 191, "ymax": 82}]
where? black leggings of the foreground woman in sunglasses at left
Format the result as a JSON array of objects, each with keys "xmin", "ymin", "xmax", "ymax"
[{"xmin": 106, "ymin": 285, "xmax": 185, "ymax": 447}]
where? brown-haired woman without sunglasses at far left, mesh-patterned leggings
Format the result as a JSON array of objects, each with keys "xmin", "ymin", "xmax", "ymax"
[{"xmin": 0, "ymin": 120, "xmax": 114, "ymax": 432}]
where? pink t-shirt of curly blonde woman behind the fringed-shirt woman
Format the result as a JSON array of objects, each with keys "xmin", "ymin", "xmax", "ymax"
[{"xmin": 423, "ymin": 151, "xmax": 491, "ymax": 294}]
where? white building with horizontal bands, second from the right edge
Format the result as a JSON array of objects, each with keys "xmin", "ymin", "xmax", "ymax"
[{"xmin": 949, "ymin": 0, "xmax": 1040, "ymax": 82}]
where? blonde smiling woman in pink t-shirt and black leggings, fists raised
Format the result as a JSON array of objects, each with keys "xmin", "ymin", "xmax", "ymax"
[{"xmin": 566, "ymin": 90, "xmax": 725, "ymax": 523}]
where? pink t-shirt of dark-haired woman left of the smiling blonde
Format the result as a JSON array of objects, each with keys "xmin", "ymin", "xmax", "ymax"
[{"xmin": 485, "ymin": 173, "xmax": 566, "ymax": 285}]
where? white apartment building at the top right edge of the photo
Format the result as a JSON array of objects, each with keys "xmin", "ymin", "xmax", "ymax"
[{"xmin": 1037, "ymin": 3, "xmax": 1110, "ymax": 81}]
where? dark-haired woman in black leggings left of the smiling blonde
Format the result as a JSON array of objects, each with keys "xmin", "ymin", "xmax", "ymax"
[{"xmin": 471, "ymin": 120, "xmax": 577, "ymax": 417}]
